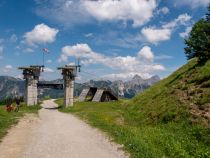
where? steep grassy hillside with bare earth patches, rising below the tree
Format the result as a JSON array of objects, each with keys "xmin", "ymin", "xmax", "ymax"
[{"xmin": 129, "ymin": 59, "xmax": 210, "ymax": 127}]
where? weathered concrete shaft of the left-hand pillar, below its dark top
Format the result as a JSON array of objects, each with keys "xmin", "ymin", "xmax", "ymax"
[{"xmin": 25, "ymin": 78, "xmax": 38, "ymax": 106}]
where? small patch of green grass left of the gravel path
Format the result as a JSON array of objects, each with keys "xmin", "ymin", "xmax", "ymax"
[{"xmin": 0, "ymin": 104, "xmax": 41, "ymax": 141}]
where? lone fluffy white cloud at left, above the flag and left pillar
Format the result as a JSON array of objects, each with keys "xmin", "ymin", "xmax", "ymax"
[{"xmin": 24, "ymin": 24, "xmax": 59, "ymax": 46}]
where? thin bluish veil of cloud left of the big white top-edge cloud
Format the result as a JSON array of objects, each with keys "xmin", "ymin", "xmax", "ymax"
[{"xmin": 35, "ymin": 0, "xmax": 91, "ymax": 27}]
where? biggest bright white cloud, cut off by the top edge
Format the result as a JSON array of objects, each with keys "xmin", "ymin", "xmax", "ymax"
[{"xmin": 83, "ymin": 0, "xmax": 157, "ymax": 26}]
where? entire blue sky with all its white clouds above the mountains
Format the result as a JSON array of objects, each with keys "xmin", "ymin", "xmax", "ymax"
[{"xmin": 0, "ymin": 0, "xmax": 210, "ymax": 82}]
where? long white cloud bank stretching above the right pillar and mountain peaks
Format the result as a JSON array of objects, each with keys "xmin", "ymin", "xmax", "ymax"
[{"xmin": 59, "ymin": 44, "xmax": 165, "ymax": 80}]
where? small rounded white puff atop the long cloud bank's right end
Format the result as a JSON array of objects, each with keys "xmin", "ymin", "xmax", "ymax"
[{"xmin": 138, "ymin": 46, "xmax": 154, "ymax": 61}]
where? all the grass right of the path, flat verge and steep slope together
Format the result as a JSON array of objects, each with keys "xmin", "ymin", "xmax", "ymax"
[{"xmin": 55, "ymin": 59, "xmax": 210, "ymax": 158}]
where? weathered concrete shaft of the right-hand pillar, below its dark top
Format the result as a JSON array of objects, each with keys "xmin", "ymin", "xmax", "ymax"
[{"xmin": 64, "ymin": 79, "xmax": 74, "ymax": 107}]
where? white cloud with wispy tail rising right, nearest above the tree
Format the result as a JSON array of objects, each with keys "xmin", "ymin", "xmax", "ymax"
[{"xmin": 141, "ymin": 14, "xmax": 191, "ymax": 44}]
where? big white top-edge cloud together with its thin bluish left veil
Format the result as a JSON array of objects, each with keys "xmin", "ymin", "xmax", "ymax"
[{"xmin": 36, "ymin": 0, "xmax": 157, "ymax": 27}]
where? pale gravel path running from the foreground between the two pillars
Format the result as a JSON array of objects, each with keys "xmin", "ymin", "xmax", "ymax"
[{"xmin": 0, "ymin": 100, "xmax": 126, "ymax": 158}]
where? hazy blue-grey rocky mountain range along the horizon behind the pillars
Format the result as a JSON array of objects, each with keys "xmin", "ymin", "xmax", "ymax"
[{"xmin": 0, "ymin": 75, "xmax": 160, "ymax": 99}]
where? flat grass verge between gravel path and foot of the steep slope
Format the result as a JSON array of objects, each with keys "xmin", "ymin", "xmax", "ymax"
[{"xmin": 56, "ymin": 100, "xmax": 210, "ymax": 158}]
